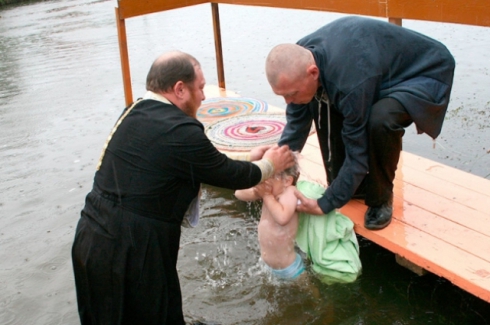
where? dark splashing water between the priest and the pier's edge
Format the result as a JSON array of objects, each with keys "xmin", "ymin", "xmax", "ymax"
[{"xmin": 178, "ymin": 186, "xmax": 490, "ymax": 325}]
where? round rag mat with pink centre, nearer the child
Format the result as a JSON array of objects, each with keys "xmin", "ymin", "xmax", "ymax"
[{"xmin": 205, "ymin": 113, "xmax": 286, "ymax": 151}]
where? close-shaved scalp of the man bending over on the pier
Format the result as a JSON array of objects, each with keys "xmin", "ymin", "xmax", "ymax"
[{"xmin": 265, "ymin": 44, "xmax": 315, "ymax": 87}]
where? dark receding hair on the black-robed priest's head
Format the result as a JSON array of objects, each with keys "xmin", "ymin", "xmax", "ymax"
[{"xmin": 146, "ymin": 51, "xmax": 200, "ymax": 93}]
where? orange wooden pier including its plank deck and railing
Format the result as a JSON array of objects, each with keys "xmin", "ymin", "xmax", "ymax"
[{"xmin": 115, "ymin": 0, "xmax": 490, "ymax": 302}]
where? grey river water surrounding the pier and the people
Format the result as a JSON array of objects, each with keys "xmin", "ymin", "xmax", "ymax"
[{"xmin": 0, "ymin": 0, "xmax": 490, "ymax": 325}]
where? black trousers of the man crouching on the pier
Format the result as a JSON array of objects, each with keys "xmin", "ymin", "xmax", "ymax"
[{"xmin": 312, "ymin": 98, "xmax": 413, "ymax": 206}]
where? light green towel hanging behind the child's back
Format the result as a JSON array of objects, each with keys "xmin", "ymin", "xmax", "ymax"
[{"xmin": 296, "ymin": 181, "xmax": 362, "ymax": 283}]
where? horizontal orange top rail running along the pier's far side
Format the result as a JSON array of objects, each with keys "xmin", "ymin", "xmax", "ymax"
[{"xmin": 114, "ymin": 0, "xmax": 490, "ymax": 26}]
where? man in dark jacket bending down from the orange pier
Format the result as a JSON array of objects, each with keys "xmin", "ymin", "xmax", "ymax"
[{"xmin": 266, "ymin": 17, "xmax": 455, "ymax": 230}]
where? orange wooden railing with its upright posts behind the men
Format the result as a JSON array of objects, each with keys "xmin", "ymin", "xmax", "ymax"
[{"xmin": 115, "ymin": 0, "xmax": 490, "ymax": 105}]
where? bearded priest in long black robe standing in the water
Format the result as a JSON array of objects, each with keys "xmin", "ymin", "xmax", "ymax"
[{"xmin": 72, "ymin": 52, "xmax": 294, "ymax": 325}]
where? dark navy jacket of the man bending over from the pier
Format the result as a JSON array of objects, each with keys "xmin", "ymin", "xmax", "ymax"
[{"xmin": 279, "ymin": 17, "xmax": 455, "ymax": 213}]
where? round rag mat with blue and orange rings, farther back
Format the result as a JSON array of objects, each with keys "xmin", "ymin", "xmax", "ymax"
[{"xmin": 197, "ymin": 97, "xmax": 268, "ymax": 125}]
